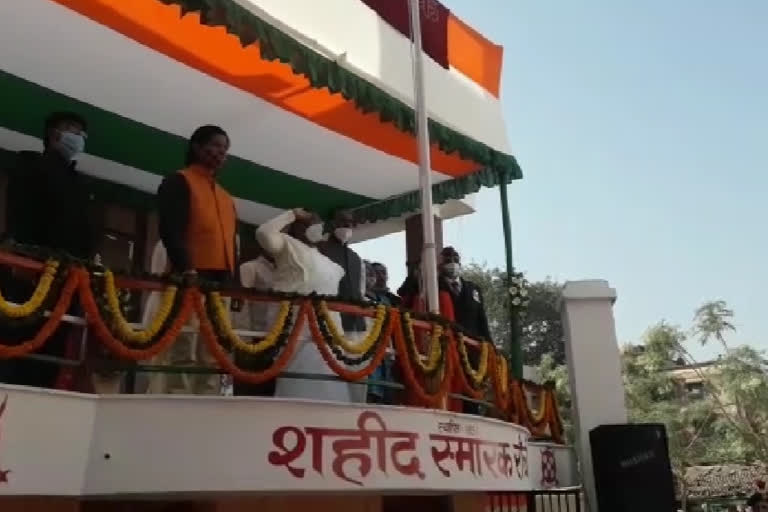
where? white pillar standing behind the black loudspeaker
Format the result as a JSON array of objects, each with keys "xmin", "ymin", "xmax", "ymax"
[{"xmin": 562, "ymin": 280, "xmax": 627, "ymax": 512}]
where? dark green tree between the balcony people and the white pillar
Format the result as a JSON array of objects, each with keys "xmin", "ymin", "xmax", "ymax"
[{"xmin": 456, "ymin": 264, "xmax": 565, "ymax": 366}]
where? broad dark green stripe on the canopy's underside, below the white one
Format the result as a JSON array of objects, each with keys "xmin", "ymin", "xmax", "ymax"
[{"xmin": 0, "ymin": 71, "xmax": 373, "ymax": 215}]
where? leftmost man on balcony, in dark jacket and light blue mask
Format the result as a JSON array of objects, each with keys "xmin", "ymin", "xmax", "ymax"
[{"xmin": 0, "ymin": 112, "xmax": 94, "ymax": 387}]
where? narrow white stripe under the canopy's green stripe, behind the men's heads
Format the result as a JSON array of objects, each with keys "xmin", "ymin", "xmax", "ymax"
[{"xmin": 0, "ymin": 127, "xmax": 282, "ymax": 224}]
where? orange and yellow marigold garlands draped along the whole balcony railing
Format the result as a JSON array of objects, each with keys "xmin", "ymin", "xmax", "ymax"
[{"xmin": 0, "ymin": 244, "xmax": 563, "ymax": 443}]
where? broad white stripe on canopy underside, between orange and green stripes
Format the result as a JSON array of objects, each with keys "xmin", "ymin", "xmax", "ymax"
[{"xmin": 0, "ymin": 0, "xmax": 456, "ymax": 199}]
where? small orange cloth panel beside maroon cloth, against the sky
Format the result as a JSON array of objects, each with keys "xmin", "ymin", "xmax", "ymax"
[{"xmin": 448, "ymin": 14, "xmax": 504, "ymax": 98}]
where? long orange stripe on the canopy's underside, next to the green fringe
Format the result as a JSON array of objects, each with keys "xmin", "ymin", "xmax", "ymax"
[{"xmin": 53, "ymin": 0, "xmax": 481, "ymax": 177}]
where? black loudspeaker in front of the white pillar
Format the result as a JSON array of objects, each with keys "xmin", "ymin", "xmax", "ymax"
[{"xmin": 589, "ymin": 424, "xmax": 677, "ymax": 512}]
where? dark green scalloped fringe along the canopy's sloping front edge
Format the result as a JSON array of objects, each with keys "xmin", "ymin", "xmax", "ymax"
[{"xmin": 154, "ymin": 0, "xmax": 523, "ymax": 183}]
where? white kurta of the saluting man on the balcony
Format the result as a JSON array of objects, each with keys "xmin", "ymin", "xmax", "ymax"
[{"xmin": 256, "ymin": 211, "xmax": 351, "ymax": 402}]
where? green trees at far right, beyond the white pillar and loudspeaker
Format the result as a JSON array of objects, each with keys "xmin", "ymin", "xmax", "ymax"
[{"xmin": 622, "ymin": 301, "xmax": 768, "ymax": 508}]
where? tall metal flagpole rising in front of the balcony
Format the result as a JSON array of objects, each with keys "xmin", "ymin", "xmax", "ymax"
[{"xmin": 408, "ymin": 0, "xmax": 440, "ymax": 313}]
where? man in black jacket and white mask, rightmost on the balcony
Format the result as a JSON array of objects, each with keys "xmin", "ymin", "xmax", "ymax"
[{"xmin": 438, "ymin": 247, "xmax": 493, "ymax": 414}]
